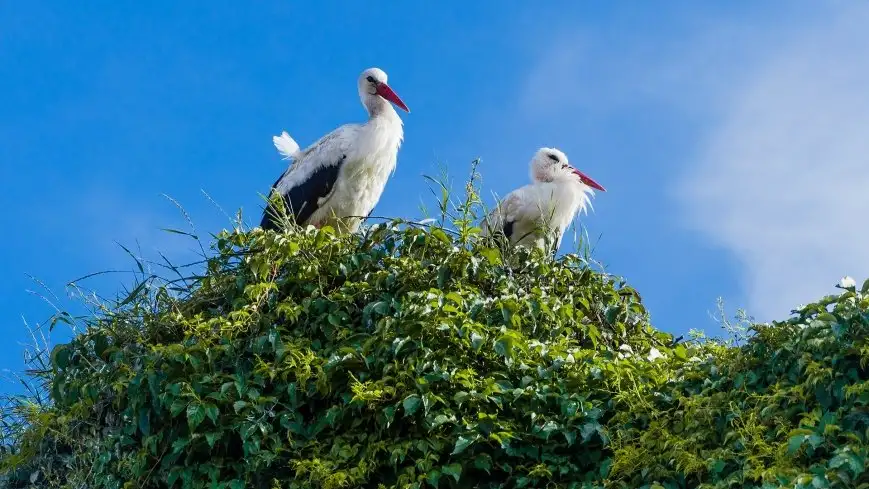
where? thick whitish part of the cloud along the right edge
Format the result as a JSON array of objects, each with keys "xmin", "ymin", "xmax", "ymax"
[{"xmin": 680, "ymin": 3, "xmax": 869, "ymax": 319}]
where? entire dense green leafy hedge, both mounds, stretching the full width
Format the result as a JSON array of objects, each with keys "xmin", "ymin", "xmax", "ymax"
[{"xmin": 2, "ymin": 219, "xmax": 869, "ymax": 489}]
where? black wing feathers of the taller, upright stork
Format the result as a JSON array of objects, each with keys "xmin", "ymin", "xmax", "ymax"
[{"xmin": 260, "ymin": 155, "xmax": 347, "ymax": 229}]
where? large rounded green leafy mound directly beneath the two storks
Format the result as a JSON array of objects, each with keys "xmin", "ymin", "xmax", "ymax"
[{"xmin": 0, "ymin": 218, "xmax": 670, "ymax": 488}]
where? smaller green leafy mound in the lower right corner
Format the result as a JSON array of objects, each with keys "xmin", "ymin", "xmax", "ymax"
[{"xmin": 611, "ymin": 281, "xmax": 869, "ymax": 488}]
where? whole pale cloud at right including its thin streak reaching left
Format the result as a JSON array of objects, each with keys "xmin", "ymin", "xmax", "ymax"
[{"xmin": 521, "ymin": 2, "xmax": 869, "ymax": 320}]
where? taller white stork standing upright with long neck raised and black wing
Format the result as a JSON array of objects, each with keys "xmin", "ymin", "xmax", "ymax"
[{"xmin": 260, "ymin": 68, "xmax": 410, "ymax": 232}]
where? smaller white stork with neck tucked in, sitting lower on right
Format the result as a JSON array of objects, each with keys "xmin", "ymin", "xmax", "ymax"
[{"xmin": 482, "ymin": 148, "xmax": 606, "ymax": 250}]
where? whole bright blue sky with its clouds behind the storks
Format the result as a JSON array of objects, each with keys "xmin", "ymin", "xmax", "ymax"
[{"xmin": 0, "ymin": 0, "xmax": 869, "ymax": 386}]
